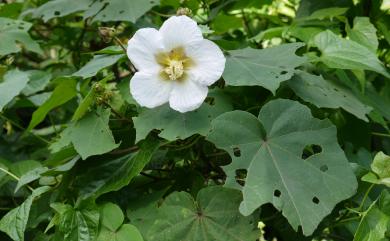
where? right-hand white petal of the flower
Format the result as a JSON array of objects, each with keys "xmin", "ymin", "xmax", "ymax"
[{"xmin": 185, "ymin": 39, "xmax": 226, "ymax": 85}]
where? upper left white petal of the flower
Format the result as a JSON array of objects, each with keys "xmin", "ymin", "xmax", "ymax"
[{"xmin": 127, "ymin": 28, "xmax": 164, "ymax": 71}]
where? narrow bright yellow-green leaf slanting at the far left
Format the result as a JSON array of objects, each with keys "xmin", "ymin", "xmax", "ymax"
[{"xmin": 27, "ymin": 78, "xmax": 77, "ymax": 131}]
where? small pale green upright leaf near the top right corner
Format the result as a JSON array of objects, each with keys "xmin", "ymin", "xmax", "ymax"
[{"xmin": 347, "ymin": 17, "xmax": 379, "ymax": 53}]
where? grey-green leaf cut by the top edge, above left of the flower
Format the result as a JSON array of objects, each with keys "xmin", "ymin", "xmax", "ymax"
[{"xmin": 84, "ymin": 0, "xmax": 159, "ymax": 23}]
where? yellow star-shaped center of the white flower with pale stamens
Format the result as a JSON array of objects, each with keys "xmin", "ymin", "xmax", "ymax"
[{"xmin": 155, "ymin": 47, "xmax": 193, "ymax": 81}]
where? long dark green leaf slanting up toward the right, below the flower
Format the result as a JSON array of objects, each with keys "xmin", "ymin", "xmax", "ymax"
[{"xmin": 78, "ymin": 137, "xmax": 159, "ymax": 199}]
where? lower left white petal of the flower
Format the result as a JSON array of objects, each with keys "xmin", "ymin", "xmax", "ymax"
[{"xmin": 130, "ymin": 72, "xmax": 173, "ymax": 108}]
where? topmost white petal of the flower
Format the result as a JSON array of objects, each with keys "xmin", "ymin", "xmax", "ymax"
[{"xmin": 159, "ymin": 16, "xmax": 203, "ymax": 51}]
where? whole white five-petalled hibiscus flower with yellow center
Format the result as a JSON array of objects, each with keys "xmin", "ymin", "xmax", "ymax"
[{"xmin": 127, "ymin": 16, "xmax": 225, "ymax": 112}]
